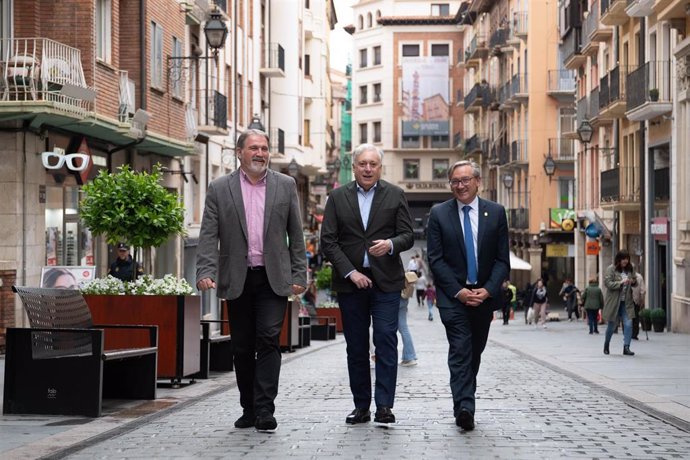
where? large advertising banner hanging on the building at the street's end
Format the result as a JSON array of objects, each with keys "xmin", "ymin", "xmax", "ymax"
[{"xmin": 402, "ymin": 56, "xmax": 450, "ymax": 136}]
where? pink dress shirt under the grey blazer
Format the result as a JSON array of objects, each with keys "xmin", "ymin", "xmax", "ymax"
[{"xmin": 240, "ymin": 169, "xmax": 268, "ymax": 267}]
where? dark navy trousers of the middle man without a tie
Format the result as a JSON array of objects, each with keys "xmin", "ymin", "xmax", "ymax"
[{"xmin": 338, "ymin": 287, "xmax": 400, "ymax": 409}]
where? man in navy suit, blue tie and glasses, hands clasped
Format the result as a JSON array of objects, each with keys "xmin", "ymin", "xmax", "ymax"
[{"xmin": 427, "ymin": 161, "xmax": 510, "ymax": 431}]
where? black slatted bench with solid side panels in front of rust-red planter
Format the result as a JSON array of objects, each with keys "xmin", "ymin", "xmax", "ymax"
[{"xmin": 3, "ymin": 286, "xmax": 158, "ymax": 417}]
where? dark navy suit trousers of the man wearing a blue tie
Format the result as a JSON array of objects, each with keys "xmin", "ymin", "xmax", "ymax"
[{"xmin": 438, "ymin": 305, "xmax": 494, "ymax": 417}]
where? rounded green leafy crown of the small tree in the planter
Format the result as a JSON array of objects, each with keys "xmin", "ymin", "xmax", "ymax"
[{"xmin": 79, "ymin": 165, "xmax": 185, "ymax": 274}]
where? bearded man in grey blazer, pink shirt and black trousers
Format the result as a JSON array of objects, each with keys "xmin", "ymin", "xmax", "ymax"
[{"xmin": 196, "ymin": 129, "xmax": 307, "ymax": 431}]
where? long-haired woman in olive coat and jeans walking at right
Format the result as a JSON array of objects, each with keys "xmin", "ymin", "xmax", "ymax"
[{"xmin": 602, "ymin": 250, "xmax": 637, "ymax": 356}]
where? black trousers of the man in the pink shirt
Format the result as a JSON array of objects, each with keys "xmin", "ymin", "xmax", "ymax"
[{"xmin": 228, "ymin": 269, "xmax": 287, "ymax": 414}]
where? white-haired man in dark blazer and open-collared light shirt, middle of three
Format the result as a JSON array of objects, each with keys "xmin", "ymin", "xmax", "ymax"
[{"xmin": 321, "ymin": 144, "xmax": 414, "ymax": 424}]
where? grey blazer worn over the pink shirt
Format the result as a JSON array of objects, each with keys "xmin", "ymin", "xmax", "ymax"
[{"xmin": 196, "ymin": 169, "xmax": 307, "ymax": 300}]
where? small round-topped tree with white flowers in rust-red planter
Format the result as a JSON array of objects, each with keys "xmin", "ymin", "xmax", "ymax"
[{"xmin": 79, "ymin": 165, "xmax": 201, "ymax": 383}]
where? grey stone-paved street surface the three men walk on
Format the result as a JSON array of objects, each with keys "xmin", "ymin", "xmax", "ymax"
[{"xmin": 0, "ymin": 302, "xmax": 690, "ymax": 459}]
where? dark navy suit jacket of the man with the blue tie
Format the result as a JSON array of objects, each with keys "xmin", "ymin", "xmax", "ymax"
[{"xmin": 427, "ymin": 198, "xmax": 510, "ymax": 309}]
